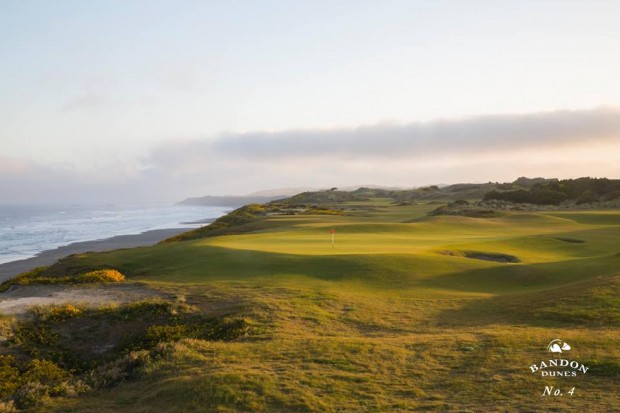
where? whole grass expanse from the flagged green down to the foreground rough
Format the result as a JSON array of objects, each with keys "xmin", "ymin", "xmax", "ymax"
[{"xmin": 40, "ymin": 199, "xmax": 620, "ymax": 412}]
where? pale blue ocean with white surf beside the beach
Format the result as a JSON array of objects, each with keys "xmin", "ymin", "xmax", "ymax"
[{"xmin": 0, "ymin": 204, "xmax": 231, "ymax": 264}]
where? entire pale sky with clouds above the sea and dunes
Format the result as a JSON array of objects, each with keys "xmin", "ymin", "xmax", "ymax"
[{"xmin": 0, "ymin": 0, "xmax": 620, "ymax": 203}]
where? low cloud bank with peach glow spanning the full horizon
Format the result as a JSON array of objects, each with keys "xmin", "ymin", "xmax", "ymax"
[{"xmin": 0, "ymin": 108, "xmax": 620, "ymax": 202}]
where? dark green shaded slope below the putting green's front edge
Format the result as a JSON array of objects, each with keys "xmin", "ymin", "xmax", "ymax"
[{"xmin": 49, "ymin": 243, "xmax": 428, "ymax": 289}]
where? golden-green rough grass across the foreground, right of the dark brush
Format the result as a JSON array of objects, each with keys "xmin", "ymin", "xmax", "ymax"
[{"xmin": 47, "ymin": 284, "xmax": 620, "ymax": 412}]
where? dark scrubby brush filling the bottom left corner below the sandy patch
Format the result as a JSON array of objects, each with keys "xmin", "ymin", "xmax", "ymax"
[{"xmin": 0, "ymin": 301, "xmax": 246, "ymax": 410}]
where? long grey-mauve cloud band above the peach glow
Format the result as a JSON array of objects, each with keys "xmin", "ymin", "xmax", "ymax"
[{"xmin": 208, "ymin": 107, "xmax": 620, "ymax": 160}]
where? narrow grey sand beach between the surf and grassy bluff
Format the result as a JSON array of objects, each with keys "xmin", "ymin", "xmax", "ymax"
[{"xmin": 0, "ymin": 228, "xmax": 192, "ymax": 282}]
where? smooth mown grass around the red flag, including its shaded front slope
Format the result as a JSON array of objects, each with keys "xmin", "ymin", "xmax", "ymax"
[{"xmin": 76, "ymin": 200, "xmax": 620, "ymax": 294}]
